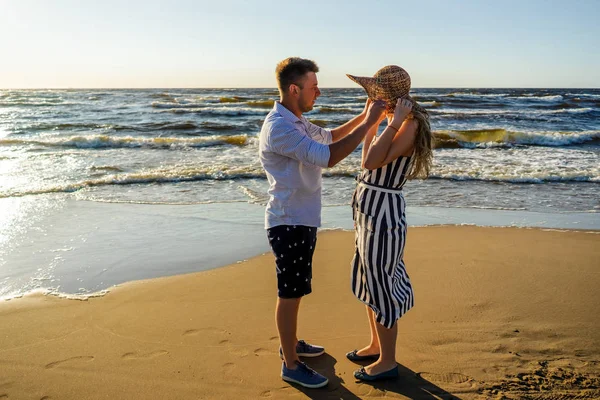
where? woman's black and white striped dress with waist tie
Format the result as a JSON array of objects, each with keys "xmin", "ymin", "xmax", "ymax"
[{"xmin": 351, "ymin": 156, "xmax": 414, "ymax": 328}]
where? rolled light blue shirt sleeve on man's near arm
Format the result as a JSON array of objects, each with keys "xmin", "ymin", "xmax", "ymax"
[{"xmin": 270, "ymin": 127, "xmax": 330, "ymax": 168}]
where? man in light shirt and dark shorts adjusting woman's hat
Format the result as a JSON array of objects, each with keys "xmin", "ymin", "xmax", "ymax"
[{"xmin": 259, "ymin": 57, "xmax": 385, "ymax": 388}]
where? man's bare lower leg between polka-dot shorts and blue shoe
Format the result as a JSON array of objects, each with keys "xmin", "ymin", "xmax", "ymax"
[{"xmin": 275, "ymin": 297, "xmax": 302, "ymax": 369}]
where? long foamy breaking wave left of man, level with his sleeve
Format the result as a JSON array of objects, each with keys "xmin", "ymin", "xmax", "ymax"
[{"xmin": 0, "ymin": 135, "xmax": 249, "ymax": 149}]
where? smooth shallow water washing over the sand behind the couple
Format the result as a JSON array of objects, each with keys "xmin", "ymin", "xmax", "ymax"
[{"xmin": 0, "ymin": 197, "xmax": 600, "ymax": 299}]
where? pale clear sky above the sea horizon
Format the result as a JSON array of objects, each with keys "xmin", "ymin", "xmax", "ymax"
[{"xmin": 0, "ymin": 0, "xmax": 600, "ymax": 88}]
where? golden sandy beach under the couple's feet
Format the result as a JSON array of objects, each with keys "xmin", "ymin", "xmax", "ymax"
[{"xmin": 0, "ymin": 226, "xmax": 600, "ymax": 400}]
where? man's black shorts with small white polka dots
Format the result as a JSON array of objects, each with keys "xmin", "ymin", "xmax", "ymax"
[{"xmin": 267, "ymin": 225, "xmax": 317, "ymax": 299}]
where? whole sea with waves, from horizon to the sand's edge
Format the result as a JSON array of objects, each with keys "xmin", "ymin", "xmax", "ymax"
[{"xmin": 0, "ymin": 88, "xmax": 600, "ymax": 299}]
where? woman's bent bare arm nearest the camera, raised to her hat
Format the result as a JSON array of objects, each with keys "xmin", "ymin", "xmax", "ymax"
[{"xmin": 363, "ymin": 99, "xmax": 418, "ymax": 170}]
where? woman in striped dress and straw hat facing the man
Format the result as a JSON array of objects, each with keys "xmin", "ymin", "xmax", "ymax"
[{"xmin": 346, "ymin": 65, "xmax": 432, "ymax": 381}]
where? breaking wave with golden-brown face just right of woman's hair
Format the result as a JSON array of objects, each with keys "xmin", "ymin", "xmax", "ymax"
[{"xmin": 434, "ymin": 129, "xmax": 600, "ymax": 148}]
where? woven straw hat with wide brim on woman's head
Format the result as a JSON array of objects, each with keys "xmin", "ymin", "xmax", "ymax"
[{"xmin": 346, "ymin": 65, "xmax": 421, "ymax": 111}]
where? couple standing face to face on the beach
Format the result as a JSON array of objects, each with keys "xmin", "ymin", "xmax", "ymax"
[{"xmin": 259, "ymin": 57, "xmax": 432, "ymax": 388}]
